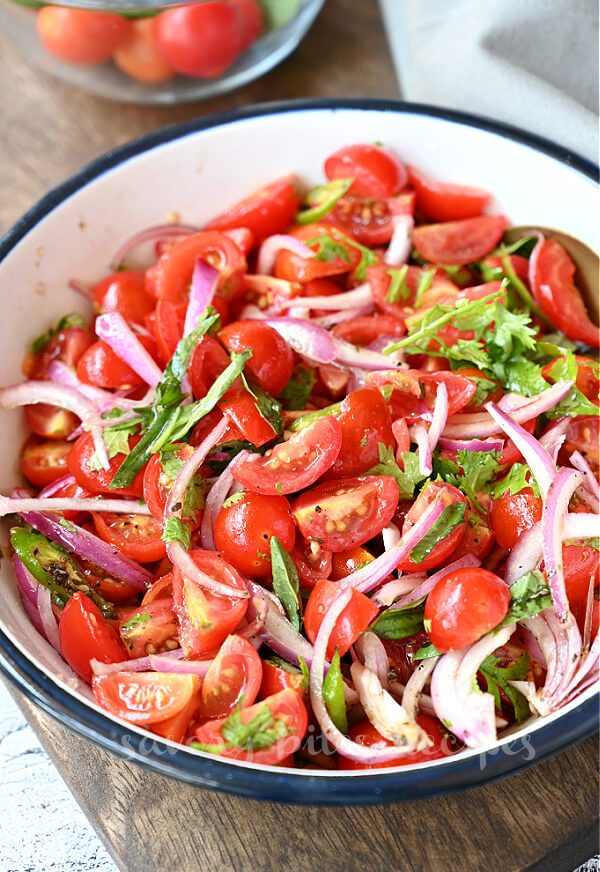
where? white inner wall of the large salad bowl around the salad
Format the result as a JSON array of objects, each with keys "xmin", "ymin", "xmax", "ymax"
[{"xmin": 0, "ymin": 107, "xmax": 599, "ymax": 781}]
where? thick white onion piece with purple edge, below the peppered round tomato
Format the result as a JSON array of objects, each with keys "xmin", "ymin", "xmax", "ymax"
[{"xmin": 431, "ymin": 624, "xmax": 515, "ymax": 748}]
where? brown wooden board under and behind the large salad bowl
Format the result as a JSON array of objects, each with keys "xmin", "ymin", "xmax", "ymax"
[{"xmin": 0, "ymin": 0, "xmax": 598, "ymax": 872}]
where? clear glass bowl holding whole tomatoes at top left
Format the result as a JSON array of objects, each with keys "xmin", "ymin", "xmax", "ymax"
[{"xmin": 0, "ymin": 0, "xmax": 325, "ymax": 106}]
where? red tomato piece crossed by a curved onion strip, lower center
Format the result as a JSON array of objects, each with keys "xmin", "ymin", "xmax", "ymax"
[{"xmin": 304, "ymin": 579, "xmax": 379, "ymax": 660}]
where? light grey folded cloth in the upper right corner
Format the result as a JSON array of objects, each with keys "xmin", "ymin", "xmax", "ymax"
[{"xmin": 379, "ymin": 0, "xmax": 598, "ymax": 163}]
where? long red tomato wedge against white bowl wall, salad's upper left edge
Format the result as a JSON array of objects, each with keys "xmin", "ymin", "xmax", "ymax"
[{"xmin": 206, "ymin": 175, "xmax": 300, "ymax": 243}]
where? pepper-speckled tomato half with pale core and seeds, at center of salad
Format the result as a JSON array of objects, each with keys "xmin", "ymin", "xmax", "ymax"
[{"xmin": 292, "ymin": 475, "xmax": 398, "ymax": 552}]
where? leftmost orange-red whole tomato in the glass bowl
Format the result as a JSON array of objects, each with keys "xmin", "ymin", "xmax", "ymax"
[{"xmin": 37, "ymin": 6, "xmax": 131, "ymax": 64}]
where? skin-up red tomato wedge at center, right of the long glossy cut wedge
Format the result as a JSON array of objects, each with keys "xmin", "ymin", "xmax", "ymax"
[{"xmin": 326, "ymin": 387, "xmax": 394, "ymax": 478}]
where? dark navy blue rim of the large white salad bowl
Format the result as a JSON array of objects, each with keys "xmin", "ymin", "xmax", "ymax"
[{"xmin": 0, "ymin": 98, "xmax": 600, "ymax": 805}]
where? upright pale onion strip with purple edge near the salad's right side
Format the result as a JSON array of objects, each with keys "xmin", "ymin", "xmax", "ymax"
[{"xmin": 540, "ymin": 470, "xmax": 583, "ymax": 621}]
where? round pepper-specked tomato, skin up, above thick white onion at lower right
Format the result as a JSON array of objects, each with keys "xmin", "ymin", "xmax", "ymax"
[{"xmin": 425, "ymin": 567, "xmax": 510, "ymax": 652}]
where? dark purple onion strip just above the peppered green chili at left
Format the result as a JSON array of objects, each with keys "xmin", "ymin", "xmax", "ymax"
[{"xmin": 20, "ymin": 508, "xmax": 154, "ymax": 590}]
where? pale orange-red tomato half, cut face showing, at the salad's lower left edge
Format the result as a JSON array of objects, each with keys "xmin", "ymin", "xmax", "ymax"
[{"xmin": 92, "ymin": 672, "xmax": 200, "ymax": 724}]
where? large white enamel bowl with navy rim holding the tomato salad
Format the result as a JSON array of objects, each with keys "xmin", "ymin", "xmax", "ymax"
[{"xmin": 0, "ymin": 101, "xmax": 600, "ymax": 802}]
